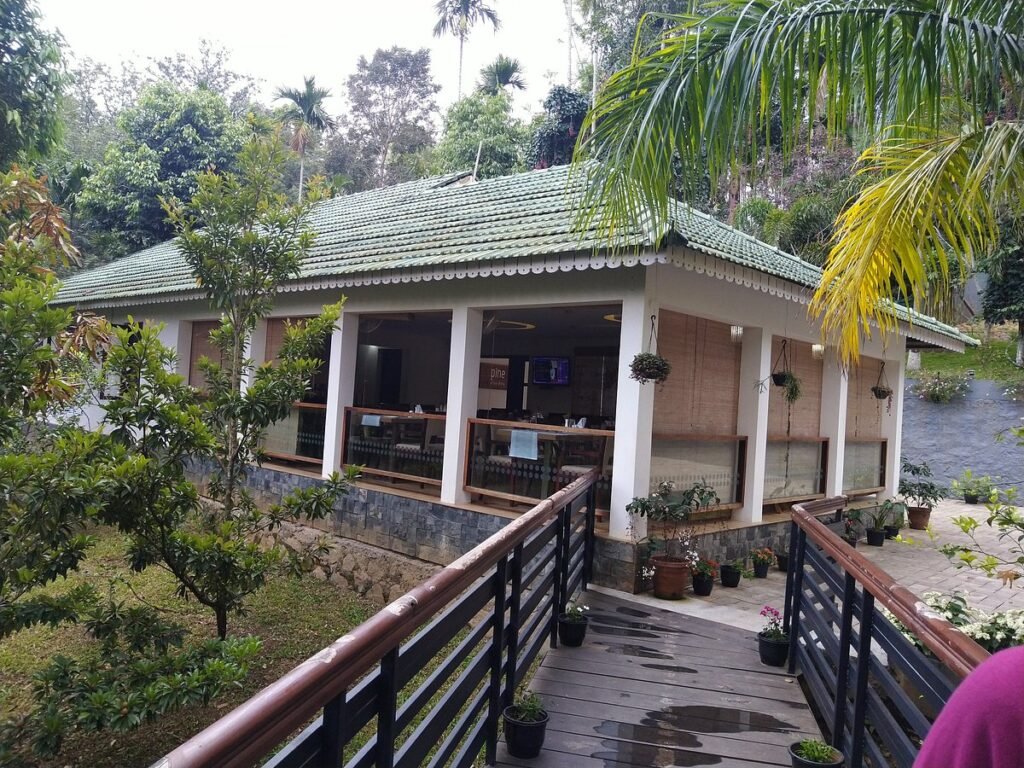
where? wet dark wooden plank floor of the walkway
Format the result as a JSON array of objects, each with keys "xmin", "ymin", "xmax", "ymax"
[{"xmin": 498, "ymin": 592, "xmax": 820, "ymax": 768}]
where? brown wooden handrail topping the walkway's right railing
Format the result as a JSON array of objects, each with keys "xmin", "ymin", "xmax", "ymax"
[{"xmin": 793, "ymin": 496, "xmax": 989, "ymax": 678}]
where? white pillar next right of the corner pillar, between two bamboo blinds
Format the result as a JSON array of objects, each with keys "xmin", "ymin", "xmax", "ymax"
[{"xmin": 736, "ymin": 327, "xmax": 771, "ymax": 522}]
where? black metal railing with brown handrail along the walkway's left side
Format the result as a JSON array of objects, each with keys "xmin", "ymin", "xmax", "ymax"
[{"xmin": 156, "ymin": 472, "xmax": 597, "ymax": 768}]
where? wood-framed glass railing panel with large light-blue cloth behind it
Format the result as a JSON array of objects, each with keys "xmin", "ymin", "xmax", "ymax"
[{"xmin": 464, "ymin": 419, "xmax": 614, "ymax": 510}]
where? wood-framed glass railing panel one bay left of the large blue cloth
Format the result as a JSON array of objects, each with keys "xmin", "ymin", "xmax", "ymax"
[{"xmin": 343, "ymin": 408, "xmax": 445, "ymax": 487}]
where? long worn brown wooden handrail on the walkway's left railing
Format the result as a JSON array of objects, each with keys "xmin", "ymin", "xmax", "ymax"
[{"xmin": 154, "ymin": 472, "xmax": 597, "ymax": 768}]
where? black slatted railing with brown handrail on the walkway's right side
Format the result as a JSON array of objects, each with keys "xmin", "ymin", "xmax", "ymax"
[{"xmin": 783, "ymin": 497, "xmax": 988, "ymax": 768}]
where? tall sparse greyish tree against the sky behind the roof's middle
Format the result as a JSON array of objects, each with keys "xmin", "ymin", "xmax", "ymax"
[{"xmin": 337, "ymin": 47, "xmax": 440, "ymax": 189}]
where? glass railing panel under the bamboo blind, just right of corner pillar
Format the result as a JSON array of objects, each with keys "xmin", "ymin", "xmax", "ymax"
[{"xmin": 650, "ymin": 434, "xmax": 746, "ymax": 505}]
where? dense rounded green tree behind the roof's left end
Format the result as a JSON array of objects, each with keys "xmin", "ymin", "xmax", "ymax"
[{"xmin": 80, "ymin": 84, "xmax": 246, "ymax": 261}]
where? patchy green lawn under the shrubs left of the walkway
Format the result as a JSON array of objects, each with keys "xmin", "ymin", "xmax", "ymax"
[{"xmin": 0, "ymin": 528, "xmax": 381, "ymax": 768}]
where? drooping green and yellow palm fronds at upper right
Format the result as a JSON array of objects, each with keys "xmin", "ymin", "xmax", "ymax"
[{"xmin": 578, "ymin": 0, "xmax": 1024, "ymax": 361}]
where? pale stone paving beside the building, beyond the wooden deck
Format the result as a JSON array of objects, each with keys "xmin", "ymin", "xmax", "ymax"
[{"xmin": 591, "ymin": 500, "xmax": 1024, "ymax": 631}]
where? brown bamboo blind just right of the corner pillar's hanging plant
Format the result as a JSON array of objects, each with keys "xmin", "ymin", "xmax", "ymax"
[{"xmin": 649, "ymin": 310, "xmax": 740, "ymax": 435}]
